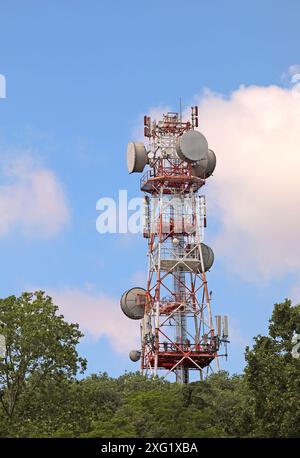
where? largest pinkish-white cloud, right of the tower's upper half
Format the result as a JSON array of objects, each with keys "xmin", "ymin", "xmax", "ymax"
[{"xmin": 188, "ymin": 86, "xmax": 300, "ymax": 280}]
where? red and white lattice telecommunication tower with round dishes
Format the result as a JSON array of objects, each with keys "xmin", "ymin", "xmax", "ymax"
[{"xmin": 121, "ymin": 106, "xmax": 228, "ymax": 383}]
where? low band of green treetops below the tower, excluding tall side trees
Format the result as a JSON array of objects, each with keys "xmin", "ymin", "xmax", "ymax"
[{"xmin": 0, "ymin": 372, "xmax": 246, "ymax": 438}]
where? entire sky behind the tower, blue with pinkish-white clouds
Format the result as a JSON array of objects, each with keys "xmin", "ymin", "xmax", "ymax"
[{"xmin": 0, "ymin": 0, "xmax": 300, "ymax": 376}]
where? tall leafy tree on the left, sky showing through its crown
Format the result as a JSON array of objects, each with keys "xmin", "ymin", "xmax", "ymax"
[{"xmin": 0, "ymin": 291, "xmax": 86, "ymax": 419}]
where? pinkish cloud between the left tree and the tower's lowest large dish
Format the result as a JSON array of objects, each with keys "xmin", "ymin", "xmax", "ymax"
[{"xmin": 49, "ymin": 288, "xmax": 139, "ymax": 354}]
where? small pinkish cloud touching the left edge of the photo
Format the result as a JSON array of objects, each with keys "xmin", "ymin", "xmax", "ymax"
[{"xmin": 0, "ymin": 153, "xmax": 69, "ymax": 238}]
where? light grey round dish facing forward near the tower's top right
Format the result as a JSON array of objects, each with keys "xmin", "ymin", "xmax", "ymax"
[{"xmin": 176, "ymin": 130, "xmax": 208, "ymax": 164}]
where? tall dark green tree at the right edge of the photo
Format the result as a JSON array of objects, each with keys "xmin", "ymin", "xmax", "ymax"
[{"xmin": 245, "ymin": 299, "xmax": 300, "ymax": 437}]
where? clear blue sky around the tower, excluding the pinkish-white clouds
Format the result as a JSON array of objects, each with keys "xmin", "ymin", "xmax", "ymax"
[{"xmin": 0, "ymin": 0, "xmax": 300, "ymax": 375}]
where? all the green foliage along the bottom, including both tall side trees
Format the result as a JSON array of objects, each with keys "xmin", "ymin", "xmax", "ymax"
[{"xmin": 0, "ymin": 292, "xmax": 300, "ymax": 438}]
